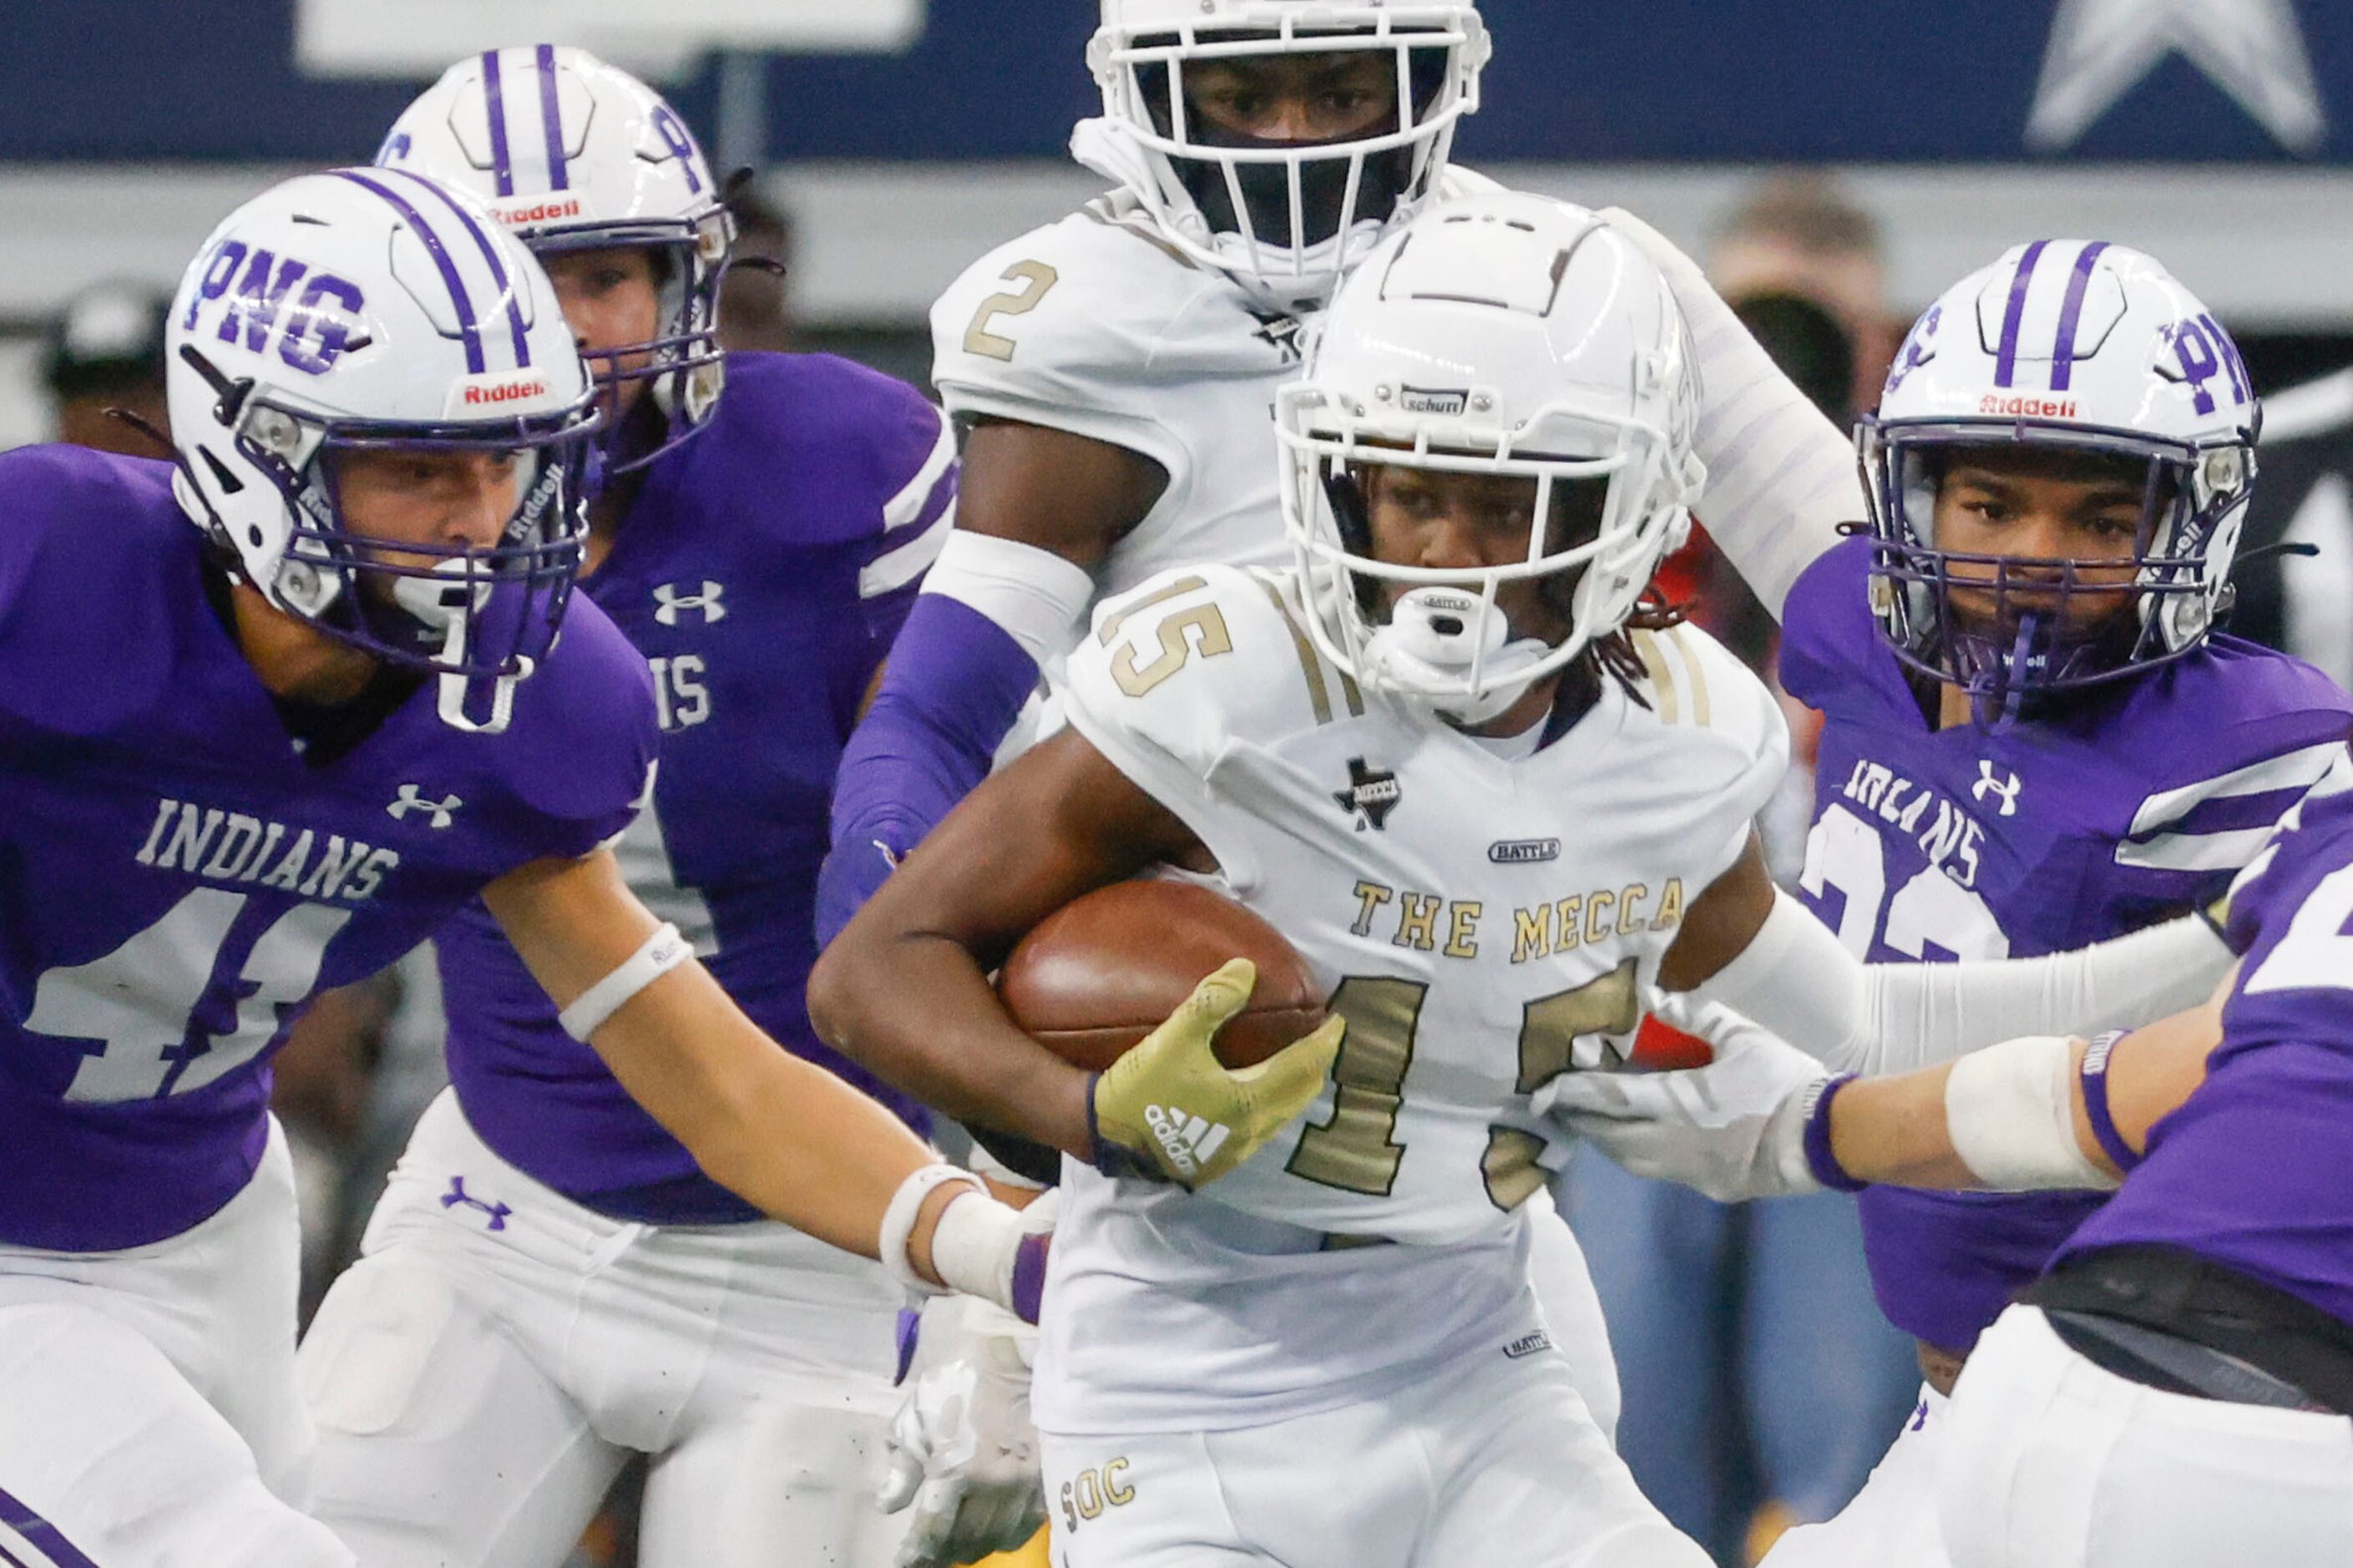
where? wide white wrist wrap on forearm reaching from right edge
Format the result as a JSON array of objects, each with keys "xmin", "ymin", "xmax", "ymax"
[{"xmin": 1944, "ymin": 1034, "xmax": 2118, "ymax": 1191}]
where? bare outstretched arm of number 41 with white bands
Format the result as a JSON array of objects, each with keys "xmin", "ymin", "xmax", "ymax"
[{"xmin": 483, "ymin": 852, "xmax": 1040, "ymax": 1307}]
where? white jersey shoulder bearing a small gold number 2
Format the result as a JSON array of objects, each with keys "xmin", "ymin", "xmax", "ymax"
[{"xmin": 932, "ymin": 200, "xmax": 1287, "ymax": 473}]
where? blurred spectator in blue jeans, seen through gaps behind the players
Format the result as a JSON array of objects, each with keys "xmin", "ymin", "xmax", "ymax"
[{"xmin": 1565, "ymin": 179, "xmax": 1918, "ymax": 1565}]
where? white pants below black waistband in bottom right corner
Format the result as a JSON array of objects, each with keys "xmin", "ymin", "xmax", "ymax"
[{"xmin": 1936, "ymin": 1307, "xmax": 2353, "ymax": 1568}]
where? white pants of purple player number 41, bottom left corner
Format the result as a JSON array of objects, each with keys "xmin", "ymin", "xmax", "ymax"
[{"xmin": 0, "ymin": 1120, "xmax": 353, "ymax": 1568}]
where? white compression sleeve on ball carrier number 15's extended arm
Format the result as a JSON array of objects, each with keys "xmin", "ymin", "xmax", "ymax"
[{"xmin": 1694, "ymin": 893, "xmax": 2230, "ymax": 1076}]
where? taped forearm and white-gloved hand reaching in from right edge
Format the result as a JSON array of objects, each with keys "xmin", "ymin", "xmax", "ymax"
[{"xmin": 1551, "ymin": 982, "xmax": 2230, "ymax": 1201}]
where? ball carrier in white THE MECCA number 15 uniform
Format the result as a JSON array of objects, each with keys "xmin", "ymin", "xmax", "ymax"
[{"xmin": 809, "ymin": 195, "xmax": 2259, "ymax": 1568}]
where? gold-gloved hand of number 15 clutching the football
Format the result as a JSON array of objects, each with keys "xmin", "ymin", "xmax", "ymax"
[{"xmin": 1094, "ymin": 959, "xmax": 1346, "ymax": 1186}]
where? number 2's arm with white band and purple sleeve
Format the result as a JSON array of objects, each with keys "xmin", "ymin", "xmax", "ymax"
[{"xmin": 817, "ymin": 419, "xmax": 1167, "ymax": 944}]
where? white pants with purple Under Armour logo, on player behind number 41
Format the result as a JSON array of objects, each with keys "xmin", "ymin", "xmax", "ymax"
[{"xmin": 301, "ymin": 1092, "xmax": 906, "ymax": 1568}]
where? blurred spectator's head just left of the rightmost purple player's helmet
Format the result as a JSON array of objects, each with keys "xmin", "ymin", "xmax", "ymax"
[{"xmin": 1708, "ymin": 175, "xmax": 1910, "ymax": 419}]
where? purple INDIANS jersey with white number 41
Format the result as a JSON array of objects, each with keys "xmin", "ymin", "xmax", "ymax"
[{"xmin": 0, "ymin": 448, "xmax": 654, "ymax": 1252}]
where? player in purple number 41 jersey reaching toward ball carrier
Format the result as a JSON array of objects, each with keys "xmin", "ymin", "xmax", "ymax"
[{"xmin": 0, "ymin": 169, "xmax": 1054, "ymax": 1568}]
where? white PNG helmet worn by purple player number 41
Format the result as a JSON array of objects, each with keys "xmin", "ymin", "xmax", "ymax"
[{"xmin": 164, "ymin": 169, "xmax": 595, "ymax": 727}]
